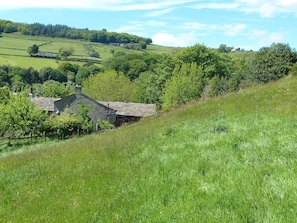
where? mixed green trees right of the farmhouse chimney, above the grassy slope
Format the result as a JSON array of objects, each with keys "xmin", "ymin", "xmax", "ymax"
[{"xmin": 83, "ymin": 43, "xmax": 297, "ymax": 110}]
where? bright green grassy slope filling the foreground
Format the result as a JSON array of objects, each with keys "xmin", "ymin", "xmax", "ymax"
[{"xmin": 0, "ymin": 77, "xmax": 297, "ymax": 223}]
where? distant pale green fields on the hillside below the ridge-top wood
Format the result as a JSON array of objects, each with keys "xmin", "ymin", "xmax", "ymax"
[{"xmin": 0, "ymin": 34, "xmax": 173, "ymax": 70}]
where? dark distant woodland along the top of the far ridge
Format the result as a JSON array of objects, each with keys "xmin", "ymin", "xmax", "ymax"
[{"xmin": 0, "ymin": 20, "xmax": 152, "ymax": 47}]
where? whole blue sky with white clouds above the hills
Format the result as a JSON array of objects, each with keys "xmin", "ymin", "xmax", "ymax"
[{"xmin": 0, "ymin": 0, "xmax": 297, "ymax": 50}]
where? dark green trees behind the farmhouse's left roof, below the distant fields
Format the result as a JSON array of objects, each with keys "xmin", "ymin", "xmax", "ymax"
[{"xmin": 0, "ymin": 62, "xmax": 102, "ymax": 98}]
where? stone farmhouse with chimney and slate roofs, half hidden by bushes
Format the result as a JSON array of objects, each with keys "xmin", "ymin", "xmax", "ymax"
[{"xmin": 31, "ymin": 86, "xmax": 156, "ymax": 128}]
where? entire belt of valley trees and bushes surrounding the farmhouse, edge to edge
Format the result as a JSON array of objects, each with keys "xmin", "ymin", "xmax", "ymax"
[{"xmin": 0, "ymin": 43, "xmax": 297, "ymax": 143}]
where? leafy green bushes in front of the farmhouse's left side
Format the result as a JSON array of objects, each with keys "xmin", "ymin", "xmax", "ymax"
[{"xmin": 0, "ymin": 91, "xmax": 100, "ymax": 139}]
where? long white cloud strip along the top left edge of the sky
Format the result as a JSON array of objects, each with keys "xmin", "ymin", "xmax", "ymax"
[{"xmin": 0, "ymin": 0, "xmax": 195, "ymax": 11}]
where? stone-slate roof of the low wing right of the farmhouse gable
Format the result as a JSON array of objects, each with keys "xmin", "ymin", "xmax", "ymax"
[{"xmin": 99, "ymin": 101, "xmax": 156, "ymax": 117}]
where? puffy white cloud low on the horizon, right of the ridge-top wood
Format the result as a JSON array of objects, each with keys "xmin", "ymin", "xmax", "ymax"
[{"xmin": 152, "ymin": 33, "xmax": 198, "ymax": 47}]
